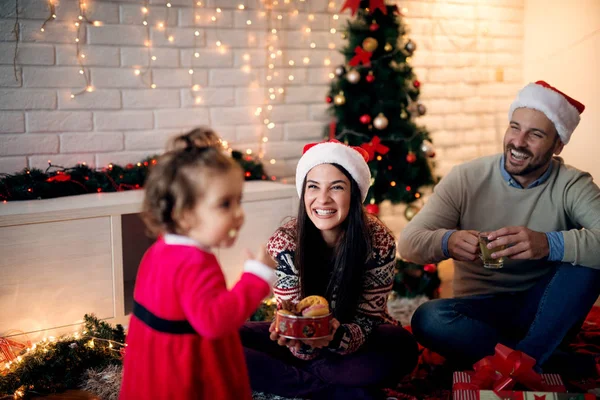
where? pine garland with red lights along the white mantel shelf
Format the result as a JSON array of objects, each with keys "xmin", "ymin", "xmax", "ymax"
[{"xmin": 0, "ymin": 151, "xmax": 267, "ymax": 202}]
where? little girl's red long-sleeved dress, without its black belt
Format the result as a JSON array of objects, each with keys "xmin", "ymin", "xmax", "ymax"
[{"xmin": 120, "ymin": 238, "xmax": 270, "ymax": 400}]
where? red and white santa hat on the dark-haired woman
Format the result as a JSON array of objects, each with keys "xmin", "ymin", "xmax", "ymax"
[{"xmin": 296, "ymin": 139, "xmax": 371, "ymax": 201}]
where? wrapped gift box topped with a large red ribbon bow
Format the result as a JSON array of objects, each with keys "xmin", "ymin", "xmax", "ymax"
[{"xmin": 452, "ymin": 344, "xmax": 595, "ymax": 400}]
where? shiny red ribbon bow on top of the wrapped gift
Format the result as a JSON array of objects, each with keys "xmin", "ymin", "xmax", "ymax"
[{"xmin": 453, "ymin": 343, "xmax": 565, "ymax": 392}]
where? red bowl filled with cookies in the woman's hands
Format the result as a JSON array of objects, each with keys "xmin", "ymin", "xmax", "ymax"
[{"xmin": 275, "ymin": 296, "xmax": 331, "ymax": 340}]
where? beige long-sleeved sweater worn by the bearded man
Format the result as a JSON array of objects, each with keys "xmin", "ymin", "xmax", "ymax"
[{"xmin": 398, "ymin": 154, "xmax": 600, "ymax": 296}]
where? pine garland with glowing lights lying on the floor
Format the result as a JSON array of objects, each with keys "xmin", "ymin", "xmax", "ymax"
[{"xmin": 0, "ymin": 314, "xmax": 125, "ymax": 398}]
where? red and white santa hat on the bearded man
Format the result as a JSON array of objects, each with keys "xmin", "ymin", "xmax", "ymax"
[{"xmin": 508, "ymin": 81, "xmax": 585, "ymax": 144}]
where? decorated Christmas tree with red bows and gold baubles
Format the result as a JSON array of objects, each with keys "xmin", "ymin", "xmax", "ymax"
[{"xmin": 326, "ymin": 0, "xmax": 435, "ymax": 214}]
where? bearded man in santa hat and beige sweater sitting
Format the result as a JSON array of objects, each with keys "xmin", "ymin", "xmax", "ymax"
[{"xmin": 399, "ymin": 81, "xmax": 600, "ymax": 368}]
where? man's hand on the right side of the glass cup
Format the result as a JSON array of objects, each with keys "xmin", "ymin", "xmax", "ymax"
[{"xmin": 488, "ymin": 226, "xmax": 550, "ymax": 260}]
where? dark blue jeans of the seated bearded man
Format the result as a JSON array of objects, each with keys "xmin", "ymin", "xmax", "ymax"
[{"xmin": 411, "ymin": 263, "xmax": 600, "ymax": 372}]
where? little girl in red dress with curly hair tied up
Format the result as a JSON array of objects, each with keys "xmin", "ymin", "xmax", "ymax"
[{"xmin": 120, "ymin": 130, "xmax": 275, "ymax": 400}]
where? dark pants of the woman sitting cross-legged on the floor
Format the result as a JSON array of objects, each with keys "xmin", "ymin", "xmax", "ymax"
[{"xmin": 240, "ymin": 322, "xmax": 418, "ymax": 400}]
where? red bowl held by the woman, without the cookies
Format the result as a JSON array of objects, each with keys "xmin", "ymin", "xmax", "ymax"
[{"xmin": 275, "ymin": 311, "xmax": 331, "ymax": 340}]
